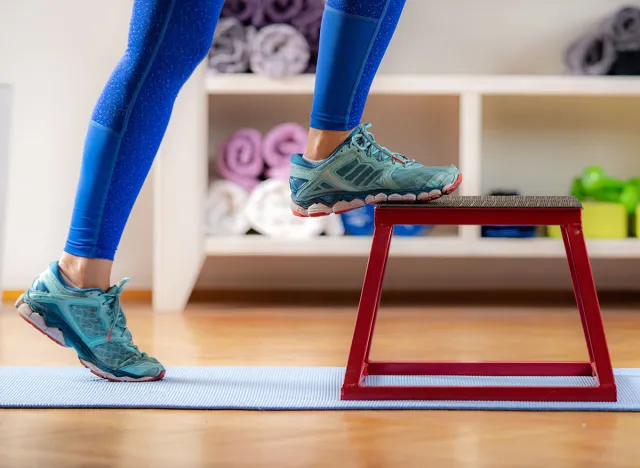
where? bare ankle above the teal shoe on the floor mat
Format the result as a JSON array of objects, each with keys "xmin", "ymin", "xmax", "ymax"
[{"xmin": 58, "ymin": 252, "xmax": 113, "ymax": 291}]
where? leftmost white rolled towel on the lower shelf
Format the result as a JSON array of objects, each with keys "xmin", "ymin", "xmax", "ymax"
[{"xmin": 205, "ymin": 180, "xmax": 251, "ymax": 236}]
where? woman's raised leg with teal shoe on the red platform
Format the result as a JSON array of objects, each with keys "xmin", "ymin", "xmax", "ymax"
[{"xmin": 291, "ymin": 0, "xmax": 461, "ymax": 216}]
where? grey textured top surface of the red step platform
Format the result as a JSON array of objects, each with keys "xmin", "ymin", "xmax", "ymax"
[{"xmin": 378, "ymin": 196, "xmax": 582, "ymax": 210}]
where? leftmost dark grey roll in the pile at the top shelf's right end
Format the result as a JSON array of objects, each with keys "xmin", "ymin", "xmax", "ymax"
[{"xmin": 565, "ymin": 33, "xmax": 617, "ymax": 76}]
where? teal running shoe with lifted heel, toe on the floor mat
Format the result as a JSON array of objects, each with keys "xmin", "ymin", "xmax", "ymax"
[{"xmin": 16, "ymin": 262, "xmax": 165, "ymax": 382}]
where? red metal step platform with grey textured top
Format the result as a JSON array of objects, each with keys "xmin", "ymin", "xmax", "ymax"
[{"xmin": 342, "ymin": 196, "xmax": 617, "ymax": 401}]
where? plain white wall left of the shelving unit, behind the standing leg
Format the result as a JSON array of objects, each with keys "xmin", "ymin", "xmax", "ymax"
[{"xmin": 0, "ymin": 0, "xmax": 152, "ymax": 289}]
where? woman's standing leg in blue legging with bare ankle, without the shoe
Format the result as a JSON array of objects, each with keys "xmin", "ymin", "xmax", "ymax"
[{"xmin": 61, "ymin": 0, "xmax": 223, "ymax": 289}]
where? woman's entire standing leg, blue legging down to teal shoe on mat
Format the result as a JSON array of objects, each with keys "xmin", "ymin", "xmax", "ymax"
[{"xmin": 17, "ymin": 0, "xmax": 223, "ymax": 381}]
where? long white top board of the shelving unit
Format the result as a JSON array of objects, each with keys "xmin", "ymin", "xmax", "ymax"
[{"xmin": 205, "ymin": 72, "xmax": 640, "ymax": 96}]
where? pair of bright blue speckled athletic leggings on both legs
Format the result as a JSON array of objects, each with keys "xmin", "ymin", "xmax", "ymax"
[{"xmin": 65, "ymin": 0, "xmax": 405, "ymax": 260}]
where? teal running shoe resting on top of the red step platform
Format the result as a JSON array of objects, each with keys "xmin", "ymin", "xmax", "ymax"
[{"xmin": 289, "ymin": 123, "xmax": 462, "ymax": 217}]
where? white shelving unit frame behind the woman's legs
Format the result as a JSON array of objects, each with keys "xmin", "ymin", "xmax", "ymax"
[{"xmin": 153, "ymin": 69, "xmax": 640, "ymax": 310}]
